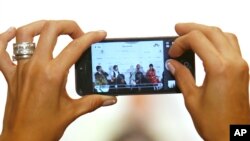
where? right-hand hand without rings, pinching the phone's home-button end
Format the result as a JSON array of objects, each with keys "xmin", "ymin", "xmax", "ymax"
[{"xmin": 167, "ymin": 23, "xmax": 250, "ymax": 141}]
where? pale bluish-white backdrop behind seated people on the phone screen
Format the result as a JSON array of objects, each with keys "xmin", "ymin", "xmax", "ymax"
[{"xmin": 92, "ymin": 41, "xmax": 165, "ymax": 84}]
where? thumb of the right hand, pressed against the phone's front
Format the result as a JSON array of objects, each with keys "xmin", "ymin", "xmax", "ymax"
[{"xmin": 166, "ymin": 59, "xmax": 197, "ymax": 100}]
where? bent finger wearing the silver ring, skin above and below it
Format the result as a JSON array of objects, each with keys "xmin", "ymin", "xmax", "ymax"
[{"xmin": 16, "ymin": 20, "xmax": 46, "ymax": 66}]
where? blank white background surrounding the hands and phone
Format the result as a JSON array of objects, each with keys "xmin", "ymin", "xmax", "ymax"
[{"xmin": 0, "ymin": 0, "xmax": 250, "ymax": 141}]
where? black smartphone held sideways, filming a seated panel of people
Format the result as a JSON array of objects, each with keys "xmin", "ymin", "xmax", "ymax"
[{"xmin": 75, "ymin": 37, "xmax": 195, "ymax": 96}]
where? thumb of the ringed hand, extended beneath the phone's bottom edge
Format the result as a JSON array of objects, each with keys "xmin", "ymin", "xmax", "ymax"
[{"xmin": 73, "ymin": 95, "xmax": 117, "ymax": 118}]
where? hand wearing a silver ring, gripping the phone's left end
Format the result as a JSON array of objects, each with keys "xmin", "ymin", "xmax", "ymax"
[{"xmin": 0, "ymin": 21, "xmax": 116, "ymax": 141}]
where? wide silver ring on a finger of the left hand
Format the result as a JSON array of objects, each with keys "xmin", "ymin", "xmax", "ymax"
[{"xmin": 13, "ymin": 42, "xmax": 35, "ymax": 61}]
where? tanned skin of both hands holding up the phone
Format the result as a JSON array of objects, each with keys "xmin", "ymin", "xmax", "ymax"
[{"xmin": 0, "ymin": 21, "xmax": 250, "ymax": 141}]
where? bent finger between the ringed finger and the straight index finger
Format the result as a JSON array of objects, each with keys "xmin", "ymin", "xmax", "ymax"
[{"xmin": 34, "ymin": 20, "xmax": 83, "ymax": 59}]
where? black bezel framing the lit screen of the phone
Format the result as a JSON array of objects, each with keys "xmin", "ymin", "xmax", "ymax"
[{"xmin": 75, "ymin": 36, "xmax": 195, "ymax": 96}]
